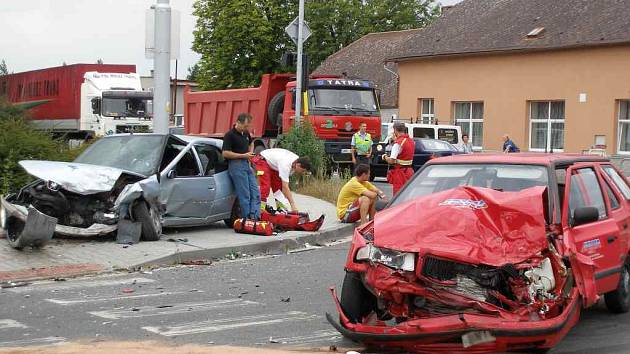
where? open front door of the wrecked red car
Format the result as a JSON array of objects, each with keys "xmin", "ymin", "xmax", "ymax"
[{"xmin": 562, "ymin": 163, "xmax": 620, "ymax": 294}]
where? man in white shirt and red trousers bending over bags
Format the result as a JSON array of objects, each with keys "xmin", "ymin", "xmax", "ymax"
[{"xmin": 252, "ymin": 149, "xmax": 311, "ymax": 212}]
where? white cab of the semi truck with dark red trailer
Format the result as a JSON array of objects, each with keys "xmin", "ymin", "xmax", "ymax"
[{"xmin": 80, "ymin": 71, "xmax": 153, "ymax": 136}]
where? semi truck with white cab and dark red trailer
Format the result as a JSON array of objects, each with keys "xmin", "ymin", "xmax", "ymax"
[{"xmin": 0, "ymin": 64, "xmax": 153, "ymax": 139}]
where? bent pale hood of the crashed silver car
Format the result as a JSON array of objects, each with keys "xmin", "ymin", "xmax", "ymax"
[{"xmin": 20, "ymin": 160, "xmax": 145, "ymax": 195}]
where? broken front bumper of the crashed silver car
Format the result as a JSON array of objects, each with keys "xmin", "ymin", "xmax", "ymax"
[{"xmin": 0, "ymin": 197, "xmax": 118, "ymax": 237}]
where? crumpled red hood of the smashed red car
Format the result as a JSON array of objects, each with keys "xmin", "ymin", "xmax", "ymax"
[{"xmin": 374, "ymin": 187, "xmax": 547, "ymax": 267}]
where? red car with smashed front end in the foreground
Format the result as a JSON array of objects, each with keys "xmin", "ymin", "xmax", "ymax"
[{"xmin": 327, "ymin": 154, "xmax": 630, "ymax": 353}]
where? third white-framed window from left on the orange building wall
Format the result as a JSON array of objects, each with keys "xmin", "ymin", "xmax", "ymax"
[{"xmin": 529, "ymin": 101, "xmax": 564, "ymax": 151}]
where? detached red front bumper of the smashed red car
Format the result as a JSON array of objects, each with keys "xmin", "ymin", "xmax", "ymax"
[{"xmin": 326, "ymin": 278, "xmax": 582, "ymax": 353}]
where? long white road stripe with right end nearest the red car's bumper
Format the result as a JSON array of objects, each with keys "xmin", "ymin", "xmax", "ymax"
[{"xmin": 142, "ymin": 311, "xmax": 320, "ymax": 337}]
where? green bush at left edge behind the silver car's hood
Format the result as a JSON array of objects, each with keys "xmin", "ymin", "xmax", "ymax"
[{"xmin": 0, "ymin": 98, "xmax": 90, "ymax": 195}]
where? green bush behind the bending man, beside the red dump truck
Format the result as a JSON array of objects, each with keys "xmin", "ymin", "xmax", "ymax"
[{"xmin": 280, "ymin": 121, "xmax": 328, "ymax": 175}]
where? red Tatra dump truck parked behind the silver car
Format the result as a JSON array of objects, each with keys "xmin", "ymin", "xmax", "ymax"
[{"xmin": 184, "ymin": 74, "xmax": 381, "ymax": 163}]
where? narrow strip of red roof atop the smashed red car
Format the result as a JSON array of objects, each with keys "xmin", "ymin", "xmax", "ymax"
[{"xmin": 429, "ymin": 152, "xmax": 610, "ymax": 165}]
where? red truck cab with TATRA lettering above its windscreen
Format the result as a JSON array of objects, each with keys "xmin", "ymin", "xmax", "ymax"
[{"xmin": 282, "ymin": 77, "xmax": 381, "ymax": 164}]
